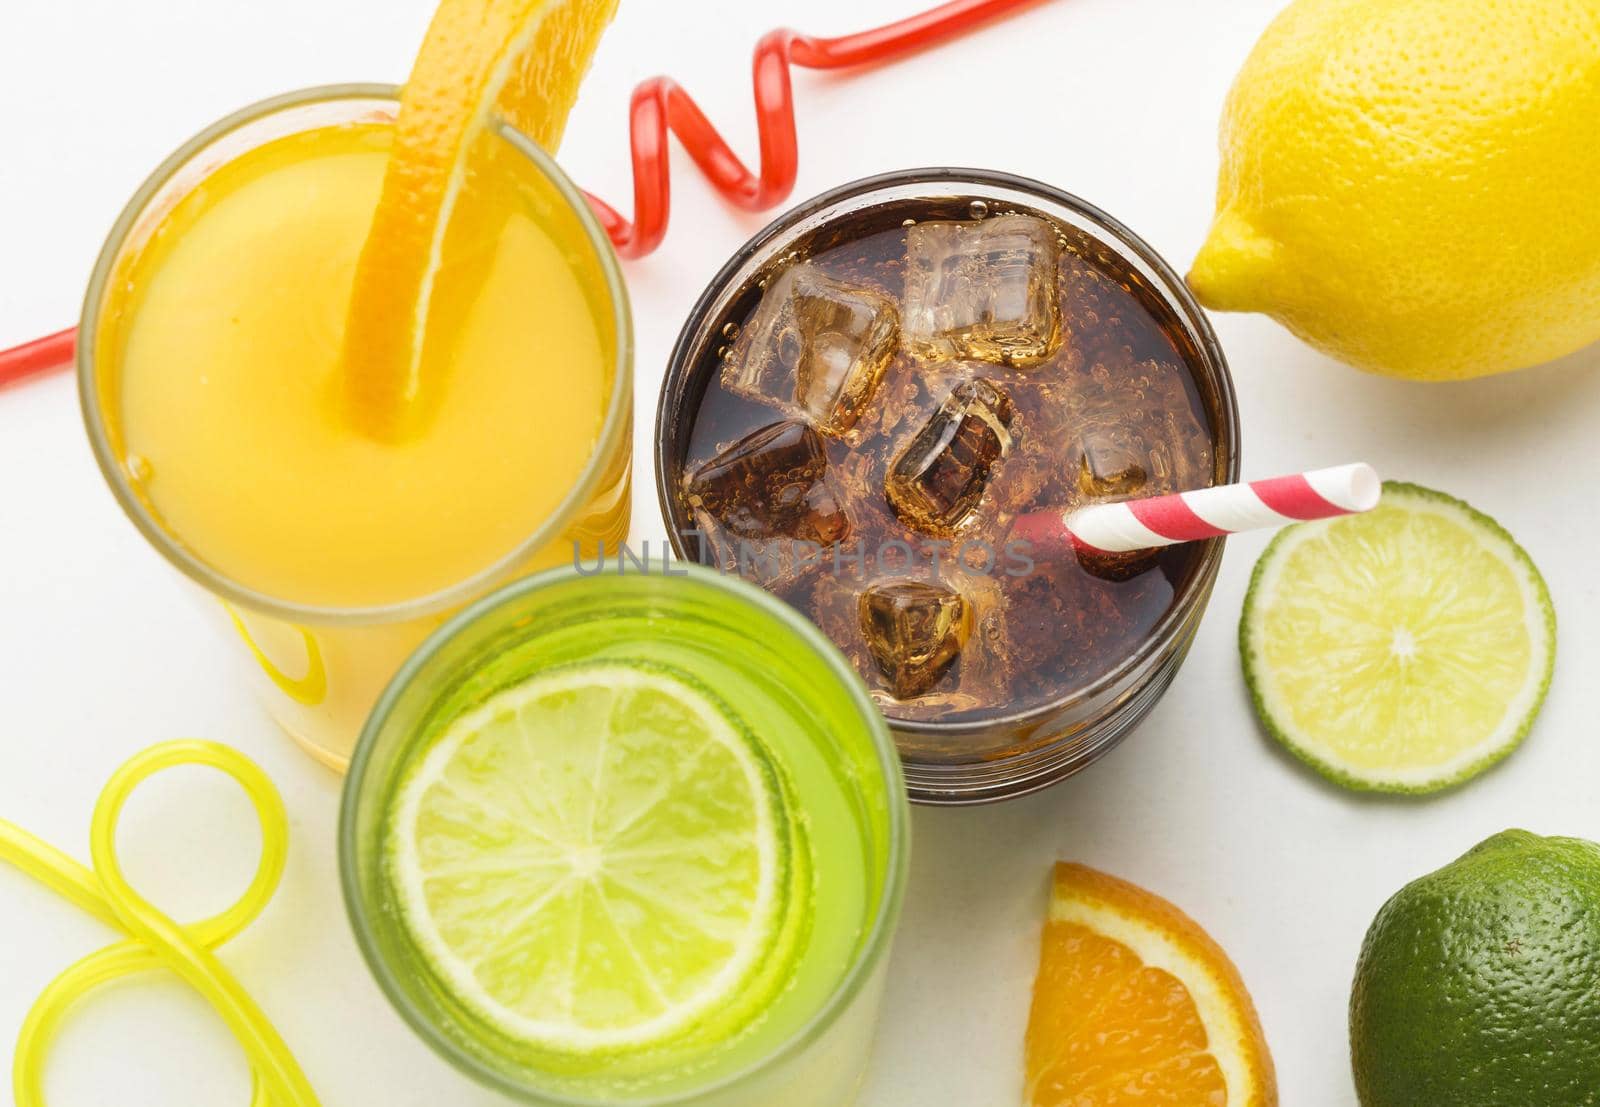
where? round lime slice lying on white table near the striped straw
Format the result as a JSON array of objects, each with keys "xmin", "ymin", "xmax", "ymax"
[{"xmin": 1238, "ymin": 482, "xmax": 1555, "ymax": 792}]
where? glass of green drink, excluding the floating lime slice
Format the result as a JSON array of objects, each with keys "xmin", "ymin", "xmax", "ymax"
[{"xmin": 339, "ymin": 565, "xmax": 909, "ymax": 1107}]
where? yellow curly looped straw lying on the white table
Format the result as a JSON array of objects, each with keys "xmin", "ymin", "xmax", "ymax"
[{"xmin": 0, "ymin": 741, "xmax": 317, "ymax": 1107}]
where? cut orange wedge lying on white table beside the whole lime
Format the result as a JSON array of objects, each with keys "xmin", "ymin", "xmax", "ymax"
[{"xmin": 1027, "ymin": 864, "xmax": 1278, "ymax": 1107}]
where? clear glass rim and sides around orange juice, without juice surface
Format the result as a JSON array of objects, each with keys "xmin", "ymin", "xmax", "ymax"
[{"xmin": 77, "ymin": 85, "xmax": 634, "ymax": 769}]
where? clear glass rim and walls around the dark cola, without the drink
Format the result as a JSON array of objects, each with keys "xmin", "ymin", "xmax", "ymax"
[{"xmin": 654, "ymin": 170, "xmax": 1238, "ymax": 805}]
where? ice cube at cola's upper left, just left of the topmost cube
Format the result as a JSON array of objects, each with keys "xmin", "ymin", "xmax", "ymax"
[{"xmin": 722, "ymin": 262, "xmax": 899, "ymax": 435}]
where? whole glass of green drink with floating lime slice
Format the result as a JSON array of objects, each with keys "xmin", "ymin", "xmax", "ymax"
[{"xmin": 341, "ymin": 566, "xmax": 907, "ymax": 1107}]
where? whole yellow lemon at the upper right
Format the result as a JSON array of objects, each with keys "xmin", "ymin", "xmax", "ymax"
[{"xmin": 1189, "ymin": 0, "xmax": 1600, "ymax": 381}]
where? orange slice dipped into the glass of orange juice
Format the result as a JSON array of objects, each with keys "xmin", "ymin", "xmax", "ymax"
[{"xmin": 342, "ymin": 0, "xmax": 618, "ymax": 438}]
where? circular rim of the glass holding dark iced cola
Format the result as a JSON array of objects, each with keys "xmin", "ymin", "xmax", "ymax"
[{"xmin": 654, "ymin": 166, "xmax": 1240, "ymax": 735}]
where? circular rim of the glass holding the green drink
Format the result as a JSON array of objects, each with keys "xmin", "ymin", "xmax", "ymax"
[{"xmin": 338, "ymin": 561, "xmax": 910, "ymax": 1107}]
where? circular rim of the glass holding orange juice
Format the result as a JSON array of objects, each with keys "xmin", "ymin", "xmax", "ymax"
[{"xmin": 75, "ymin": 83, "xmax": 634, "ymax": 625}]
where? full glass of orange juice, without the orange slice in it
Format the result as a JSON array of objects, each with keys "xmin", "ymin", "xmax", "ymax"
[{"xmin": 77, "ymin": 85, "xmax": 634, "ymax": 768}]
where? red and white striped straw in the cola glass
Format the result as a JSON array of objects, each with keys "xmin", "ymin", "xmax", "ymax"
[{"xmin": 1011, "ymin": 464, "xmax": 1382, "ymax": 554}]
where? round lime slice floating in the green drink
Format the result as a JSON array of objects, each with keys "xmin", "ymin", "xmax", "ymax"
[{"xmin": 389, "ymin": 661, "xmax": 798, "ymax": 1056}]
